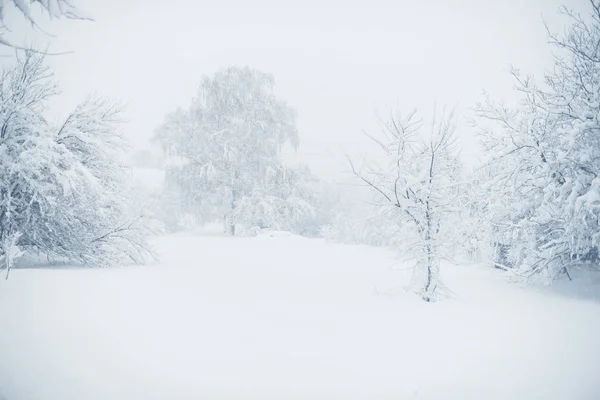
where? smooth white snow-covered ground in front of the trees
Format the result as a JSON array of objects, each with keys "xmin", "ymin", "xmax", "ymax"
[{"xmin": 0, "ymin": 234, "xmax": 600, "ymax": 400}]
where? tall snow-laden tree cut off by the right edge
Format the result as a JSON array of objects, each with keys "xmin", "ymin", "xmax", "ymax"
[{"xmin": 478, "ymin": 0, "xmax": 600, "ymax": 282}]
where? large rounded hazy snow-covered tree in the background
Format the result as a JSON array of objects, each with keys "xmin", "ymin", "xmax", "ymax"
[{"xmin": 156, "ymin": 67, "xmax": 309, "ymax": 235}]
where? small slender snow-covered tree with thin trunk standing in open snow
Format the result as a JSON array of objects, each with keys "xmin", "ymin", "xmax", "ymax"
[{"xmin": 350, "ymin": 108, "xmax": 460, "ymax": 302}]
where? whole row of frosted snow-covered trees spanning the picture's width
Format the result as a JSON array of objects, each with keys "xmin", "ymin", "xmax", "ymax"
[{"xmin": 0, "ymin": 1, "xmax": 600, "ymax": 301}]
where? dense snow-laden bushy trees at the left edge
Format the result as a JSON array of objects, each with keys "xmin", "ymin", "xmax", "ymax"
[{"xmin": 0, "ymin": 52, "xmax": 151, "ymax": 265}]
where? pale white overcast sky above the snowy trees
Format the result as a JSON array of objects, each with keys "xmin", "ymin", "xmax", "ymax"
[{"xmin": 1, "ymin": 0, "xmax": 587, "ymax": 178}]
